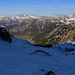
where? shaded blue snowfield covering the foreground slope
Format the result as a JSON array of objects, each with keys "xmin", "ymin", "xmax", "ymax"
[{"xmin": 0, "ymin": 38, "xmax": 75, "ymax": 75}]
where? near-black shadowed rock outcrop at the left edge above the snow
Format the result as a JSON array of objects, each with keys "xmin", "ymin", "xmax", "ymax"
[{"xmin": 0, "ymin": 28, "xmax": 12, "ymax": 43}]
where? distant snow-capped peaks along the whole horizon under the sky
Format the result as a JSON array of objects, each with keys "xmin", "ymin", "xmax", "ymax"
[{"xmin": 0, "ymin": 14, "xmax": 75, "ymax": 26}]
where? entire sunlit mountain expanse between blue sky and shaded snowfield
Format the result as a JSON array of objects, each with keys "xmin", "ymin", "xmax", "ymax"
[{"xmin": 0, "ymin": 14, "xmax": 75, "ymax": 45}]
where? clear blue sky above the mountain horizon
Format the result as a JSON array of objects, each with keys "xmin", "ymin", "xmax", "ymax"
[{"xmin": 0, "ymin": 0, "xmax": 75, "ymax": 16}]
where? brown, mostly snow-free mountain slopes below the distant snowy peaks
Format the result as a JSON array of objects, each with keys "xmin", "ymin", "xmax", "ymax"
[{"xmin": 7, "ymin": 19, "xmax": 75, "ymax": 45}]
